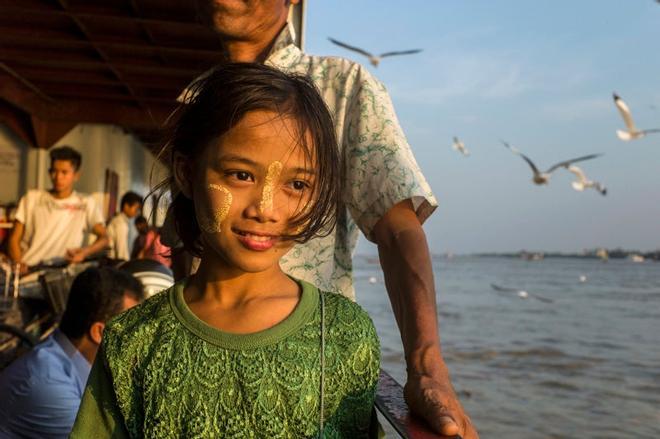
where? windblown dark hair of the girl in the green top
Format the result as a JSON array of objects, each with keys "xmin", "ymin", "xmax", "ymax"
[{"xmin": 159, "ymin": 63, "xmax": 343, "ymax": 256}]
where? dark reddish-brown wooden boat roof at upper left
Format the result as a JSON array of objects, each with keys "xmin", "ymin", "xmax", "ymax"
[{"xmin": 0, "ymin": 0, "xmax": 227, "ymax": 148}]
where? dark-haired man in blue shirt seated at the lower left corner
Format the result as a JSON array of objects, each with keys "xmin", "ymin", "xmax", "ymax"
[{"xmin": 0, "ymin": 268, "xmax": 144, "ymax": 438}]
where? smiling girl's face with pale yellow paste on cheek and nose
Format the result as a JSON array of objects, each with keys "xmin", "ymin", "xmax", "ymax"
[{"xmin": 191, "ymin": 111, "xmax": 316, "ymax": 273}]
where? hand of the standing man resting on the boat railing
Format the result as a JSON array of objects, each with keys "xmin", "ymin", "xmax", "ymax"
[{"xmin": 403, "ymin": 374, "xmax": 479, "ymax": 439}]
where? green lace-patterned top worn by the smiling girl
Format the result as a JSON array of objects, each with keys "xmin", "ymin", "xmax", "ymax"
[{"xmin": 71, "ymin": 281, "xmax": 379, "ymax": 439}]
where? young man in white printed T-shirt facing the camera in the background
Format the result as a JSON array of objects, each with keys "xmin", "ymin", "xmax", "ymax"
[{"xmin": 9, "ymin": 146, "xmax": 108, "ymax": 273}]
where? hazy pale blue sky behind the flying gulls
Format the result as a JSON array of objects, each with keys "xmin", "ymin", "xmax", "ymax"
[{"xmin": 305, "ymin": 0, "xmax": 660, "ymax": 253}]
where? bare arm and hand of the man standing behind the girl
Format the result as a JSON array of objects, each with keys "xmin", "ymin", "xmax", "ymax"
[{"xmin": 374, "ymin": 200, "xmax": 479, "ymax": 439}]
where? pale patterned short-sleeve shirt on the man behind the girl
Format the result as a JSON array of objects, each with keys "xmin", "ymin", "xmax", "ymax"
[{"xmin": 173, "ymin": 26, "xmax": 437, "ymax": 299}]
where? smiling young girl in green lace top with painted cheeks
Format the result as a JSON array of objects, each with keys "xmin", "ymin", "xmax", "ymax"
[{"xmin": 71, "ymin": 64, "xmax": 379, "ymax": 438}]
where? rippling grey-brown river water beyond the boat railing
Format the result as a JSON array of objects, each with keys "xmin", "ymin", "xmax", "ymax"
[{"xmin": 355, "ymin": 257, "xmax": 660, "ymax": 438}]
